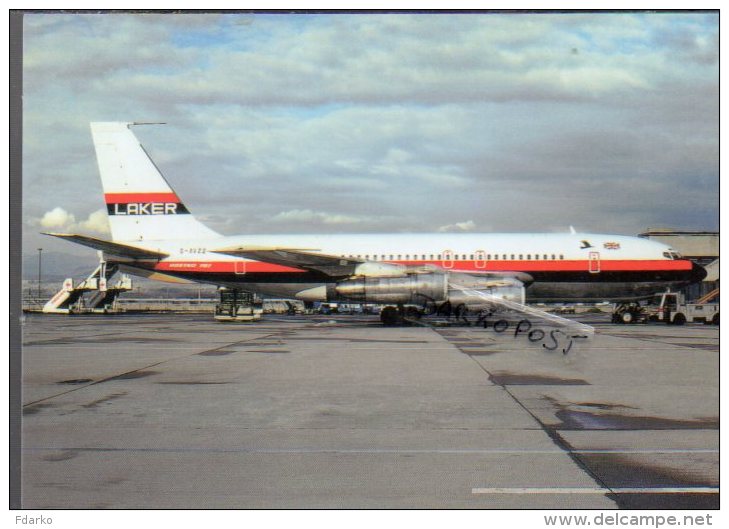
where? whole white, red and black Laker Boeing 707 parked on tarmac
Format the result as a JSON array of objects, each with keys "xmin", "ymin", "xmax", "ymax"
[{"xmin": 49, "ymin": 122, "xmax": 706, "ymax": 323}]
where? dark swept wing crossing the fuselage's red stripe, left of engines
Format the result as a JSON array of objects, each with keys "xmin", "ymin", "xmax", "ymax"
[{"xmin": 213, "ymin": 246, "xmax": 365, "ymax": 277}]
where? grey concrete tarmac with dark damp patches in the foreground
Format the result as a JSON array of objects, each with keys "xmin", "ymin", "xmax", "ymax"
[{"xmin": 21, "ymin": 314, "xmax": 719, "ymax": 509}]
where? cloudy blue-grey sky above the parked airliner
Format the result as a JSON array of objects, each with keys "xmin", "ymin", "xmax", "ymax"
[{"xmin": 23, "ymin": 12, "xmax": 719, "ymax": 253}]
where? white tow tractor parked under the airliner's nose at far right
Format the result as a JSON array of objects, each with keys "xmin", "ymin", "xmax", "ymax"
[{"xmin": 613, "ymin": 288, "xmax": 719, "ymax": 325}]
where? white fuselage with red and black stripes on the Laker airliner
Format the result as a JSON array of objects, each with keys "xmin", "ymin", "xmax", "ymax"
[{"xmin": 116, "ymin": 233, "xmax": 700, "ymax": 301}]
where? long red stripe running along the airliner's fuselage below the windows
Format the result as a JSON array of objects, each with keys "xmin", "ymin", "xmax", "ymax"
[{"xmin": 154, "ymin": 260, "xmax": 691, "ymax": 274}]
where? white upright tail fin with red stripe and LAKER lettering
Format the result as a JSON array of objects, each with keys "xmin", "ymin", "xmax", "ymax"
[{"xmin": 91, "ymin": 122, "xmax": 219, "ymax": 241}]
